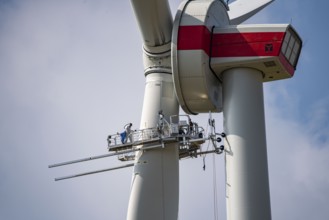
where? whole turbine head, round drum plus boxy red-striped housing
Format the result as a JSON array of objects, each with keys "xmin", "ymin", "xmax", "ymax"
[{"xmin": 171, "ymin": 0, "xmax": 302, "ymax": 114}]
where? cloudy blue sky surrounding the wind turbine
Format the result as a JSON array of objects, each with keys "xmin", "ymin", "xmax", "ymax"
[{"xmin": 0, "ymin": 0, "xmax": 329, "ymax": 220}]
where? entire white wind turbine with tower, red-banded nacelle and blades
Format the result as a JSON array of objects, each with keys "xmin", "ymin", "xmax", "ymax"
[{"xmin": 50, "ymin": 0, "xmax": 302, "ymax": 220}]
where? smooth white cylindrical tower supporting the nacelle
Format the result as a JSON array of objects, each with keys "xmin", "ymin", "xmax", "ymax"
[{"xmin": 223, "ymin": 68, "xmax": 271, "ymax": 220}]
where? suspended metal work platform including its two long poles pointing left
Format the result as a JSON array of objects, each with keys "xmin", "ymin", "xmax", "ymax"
[{"xmin": 48, "ymin": 112, "xmax": 225, "ymax": 181}]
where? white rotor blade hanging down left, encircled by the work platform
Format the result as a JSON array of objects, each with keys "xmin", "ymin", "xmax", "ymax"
[{"xmin": 127, "ymin": 0, "xmax": 179, "ymax": 220}]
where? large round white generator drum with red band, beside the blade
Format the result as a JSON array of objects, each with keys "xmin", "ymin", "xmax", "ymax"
[{"xmin": 171, "ymin": 0, "xmax": 229, "ymax": 114}]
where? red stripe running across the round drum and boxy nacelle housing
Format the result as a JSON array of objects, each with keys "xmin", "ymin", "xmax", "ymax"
[{"xmin": 177, "ymin": 25, "xmax": 284, "ymax": 57}]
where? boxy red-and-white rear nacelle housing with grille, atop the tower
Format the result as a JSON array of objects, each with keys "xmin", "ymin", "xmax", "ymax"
[{"xmin": 211, "ymin": 24, "xmax": 302, "ymax": 82}]
